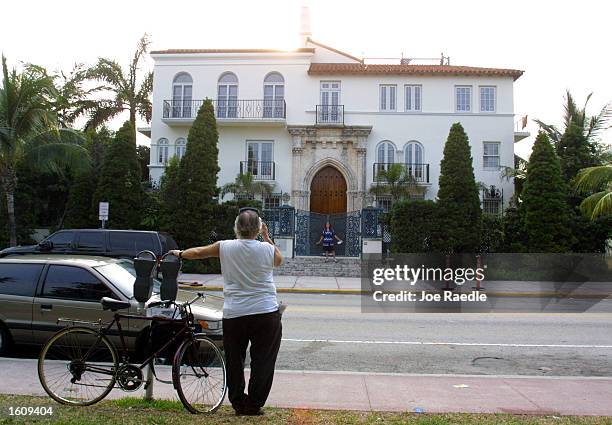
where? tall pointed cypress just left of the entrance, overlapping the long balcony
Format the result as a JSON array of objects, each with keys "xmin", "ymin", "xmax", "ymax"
[{"xmin": 175, "ymin": 99, "xmax": 219, "ymax": 247}]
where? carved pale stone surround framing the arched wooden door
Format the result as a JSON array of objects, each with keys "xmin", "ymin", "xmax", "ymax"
[{"xmin": 287, "ymin": 126, "xmax": 372, "ymax": 211}]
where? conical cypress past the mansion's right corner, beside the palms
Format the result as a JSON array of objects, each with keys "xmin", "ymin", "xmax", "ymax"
[{"xmin": 520, "ymin": 132, "xmax": 572, "ymax": 252}]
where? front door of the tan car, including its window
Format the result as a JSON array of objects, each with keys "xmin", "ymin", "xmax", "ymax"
[{"xmin": 32, "ymin": 264, "xmax": 122, "ymax": 343}]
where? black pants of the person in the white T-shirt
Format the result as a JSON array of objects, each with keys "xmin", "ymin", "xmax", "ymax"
[{"xmin": 223, "ymin": 311, "xmax": 283, "ymax": 411}]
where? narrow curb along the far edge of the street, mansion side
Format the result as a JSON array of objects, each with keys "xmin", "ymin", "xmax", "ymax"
[{"xmin": 179, "ymin": 284, "xmax": 611, "ymax": 299}]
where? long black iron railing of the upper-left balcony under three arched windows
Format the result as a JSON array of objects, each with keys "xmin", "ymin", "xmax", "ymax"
[{"xmin": 163, "ymin": 98, "xmax": 287, "ymax": 120}]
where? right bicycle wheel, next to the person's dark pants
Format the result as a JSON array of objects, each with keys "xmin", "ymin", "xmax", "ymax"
[{"xmin": 172, "ymin": 335, "xmax": 227, "ymax": 413}]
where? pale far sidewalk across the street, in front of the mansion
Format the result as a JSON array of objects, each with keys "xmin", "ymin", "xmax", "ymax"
[{"xmin": 178, "ymin": 273, "xmax": 612, "ymax": 299}]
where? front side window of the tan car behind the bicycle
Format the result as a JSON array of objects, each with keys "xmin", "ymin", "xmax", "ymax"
[{"xmin": 42, "ymin": 265, "xmax": 117, "ymax": 301}]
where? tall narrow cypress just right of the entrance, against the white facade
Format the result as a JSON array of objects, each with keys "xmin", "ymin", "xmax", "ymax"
[{"xmin": 435, "ymin": 123, "xmax": 482, "ymax": 253}]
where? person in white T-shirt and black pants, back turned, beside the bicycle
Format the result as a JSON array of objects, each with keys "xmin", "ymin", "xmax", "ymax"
[{"xmin": 171, "ymin": 208, "xmax": 283, "ymax": 415}]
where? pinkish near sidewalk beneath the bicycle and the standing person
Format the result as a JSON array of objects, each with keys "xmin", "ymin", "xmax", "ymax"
[{"xmin": 0, "ymin": 359, "xmax": 612, "ymax": 416}]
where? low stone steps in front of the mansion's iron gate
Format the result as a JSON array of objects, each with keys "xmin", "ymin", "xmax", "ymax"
[{"xmin": 274, "ymin": 257, "xmax": 361, "ymax": 277}]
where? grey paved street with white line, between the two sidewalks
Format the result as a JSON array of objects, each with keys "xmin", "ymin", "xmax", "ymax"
[{"xmin": 278, "ymin": 294, "xmax": 612, "ymax": 376}]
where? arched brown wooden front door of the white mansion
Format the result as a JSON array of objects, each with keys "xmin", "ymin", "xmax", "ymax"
[{"xmin": 310, "ymin": 166, "xmax": 346, "ymax": 214}]
